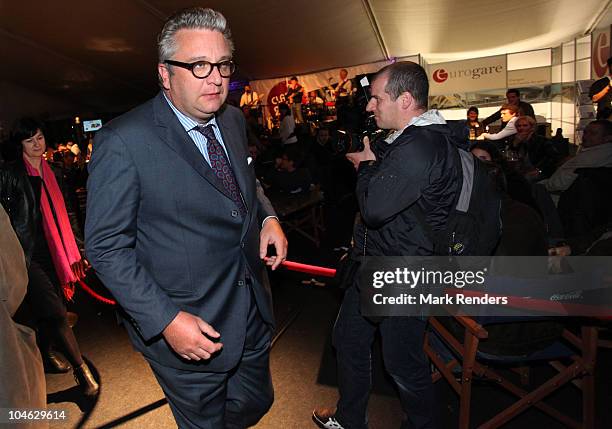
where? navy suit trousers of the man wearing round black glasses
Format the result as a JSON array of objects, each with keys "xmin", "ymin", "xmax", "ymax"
[{"xmin": 148, "ymin": 286, "xmax": 274, "ymax": 429}]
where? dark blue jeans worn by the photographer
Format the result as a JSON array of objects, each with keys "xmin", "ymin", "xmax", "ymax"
[{"xmin": 333, "ymin": 286, "xmax": 434, "ymax": 429}]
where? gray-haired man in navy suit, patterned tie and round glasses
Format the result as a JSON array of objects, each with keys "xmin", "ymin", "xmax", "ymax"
[{"xmin": 85, "ymin": 8, "xmax": 287, "ymax": 428}]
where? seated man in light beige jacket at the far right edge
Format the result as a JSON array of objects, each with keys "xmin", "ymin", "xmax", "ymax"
[{"xmin": 546, "ymin": 119, "xmax": 612, "ymax": 192}]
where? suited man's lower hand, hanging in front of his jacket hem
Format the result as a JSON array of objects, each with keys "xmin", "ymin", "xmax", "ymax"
[{"xmin": 162, "ymin": 311, "xmax": 223, "ymax": 361}]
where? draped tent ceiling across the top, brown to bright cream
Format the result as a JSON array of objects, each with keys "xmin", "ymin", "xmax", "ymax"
[{"xmin": 0, "ymin": 0, "xmax": 612, "ymax": 113}]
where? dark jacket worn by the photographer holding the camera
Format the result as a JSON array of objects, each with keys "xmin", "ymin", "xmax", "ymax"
[{"xmin": 355, "ymin": 124, "xmax": 461, "ymax": 256}]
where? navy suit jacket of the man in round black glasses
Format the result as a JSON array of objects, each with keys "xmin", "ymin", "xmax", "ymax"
[{"xmin": 85, "ymin": 93, "xmax": 274, "ymax": 372}]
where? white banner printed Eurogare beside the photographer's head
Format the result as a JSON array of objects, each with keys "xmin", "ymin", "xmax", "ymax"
[{"xmin": 427, "ymin": 55, "xmax": 506, "ymax": 95}]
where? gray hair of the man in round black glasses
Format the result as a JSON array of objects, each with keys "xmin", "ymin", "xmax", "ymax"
[{"xmin": 157, "ymin": 7, "xmax": 234, "ymax": 63}]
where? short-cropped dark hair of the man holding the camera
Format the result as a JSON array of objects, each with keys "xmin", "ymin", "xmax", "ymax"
[{"xmin": 373, "ymin": 61, "xmax": 429, "ymax": 109}]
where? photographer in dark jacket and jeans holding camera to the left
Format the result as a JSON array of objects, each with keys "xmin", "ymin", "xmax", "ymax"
[{"xmin": 313, "ymin": 62, "xmax": 460, "ymax": 429}]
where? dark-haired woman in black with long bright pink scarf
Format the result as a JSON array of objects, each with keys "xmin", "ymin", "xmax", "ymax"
[{"xmin": 0, "ymin": 118, "xmax": 99, "ymax": 396}]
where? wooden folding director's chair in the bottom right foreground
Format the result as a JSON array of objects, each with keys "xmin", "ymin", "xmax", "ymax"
[{"xmin": 424, "ymin": 313, "xmax": 598, "ymax": 429}]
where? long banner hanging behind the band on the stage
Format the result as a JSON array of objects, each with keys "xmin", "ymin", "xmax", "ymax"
[{"xmin": 250, "ymin": 55, "xmax": 420, "ymax": 116}]
